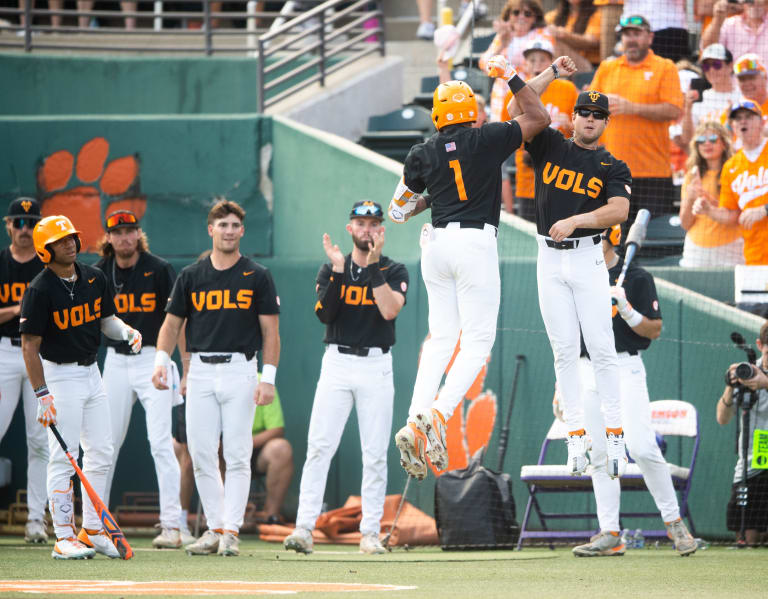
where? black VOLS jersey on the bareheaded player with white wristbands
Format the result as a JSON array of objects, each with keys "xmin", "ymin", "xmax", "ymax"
[{"xmin": 166, "ymin": 256, "xmax": 280, "ymax": 357}]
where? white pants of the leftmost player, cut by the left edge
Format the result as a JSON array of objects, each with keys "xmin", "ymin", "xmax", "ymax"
[{"xmin": 0, "ymin": 337, "xmax": 48, "ymax": 520}]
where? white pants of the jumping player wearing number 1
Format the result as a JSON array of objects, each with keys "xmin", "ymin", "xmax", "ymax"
[{"xmin": 409, "ymin": 223, "xmax": 501, "ymax": 420}]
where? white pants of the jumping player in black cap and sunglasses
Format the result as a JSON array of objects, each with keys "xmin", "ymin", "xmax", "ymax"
[{"xmin": 536, "ymin": 235, "xmax": 621, "ymax": 436}]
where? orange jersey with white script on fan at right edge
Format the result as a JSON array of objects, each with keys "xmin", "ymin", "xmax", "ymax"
[{"xmin": 720, "ymin": 140, "xmax": 768, "ymax": 265}]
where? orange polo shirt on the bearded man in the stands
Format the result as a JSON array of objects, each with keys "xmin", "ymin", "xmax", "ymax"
[{"xmin": 591, "ymin": 50, "xmax": 683, "ymax": 178}]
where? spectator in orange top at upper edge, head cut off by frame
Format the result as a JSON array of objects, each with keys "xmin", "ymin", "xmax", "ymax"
[{"xmin": 544, "ymin": 0, "xmax": 600, "ymax": 72}]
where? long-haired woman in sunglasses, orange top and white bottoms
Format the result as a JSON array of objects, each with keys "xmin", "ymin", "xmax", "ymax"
[{"xmin": 680, "ymin": 121, "xmax": 744, "ymax": 267}]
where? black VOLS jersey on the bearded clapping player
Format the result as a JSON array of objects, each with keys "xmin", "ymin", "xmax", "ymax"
[{"xmin": 315, "ymin": 254, "xmax": 408, "ymax": 348}]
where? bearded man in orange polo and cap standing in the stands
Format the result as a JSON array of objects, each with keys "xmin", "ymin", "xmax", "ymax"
[{"xmin": 590, "ymin": 15, "xmax": 683, "ymax": 223}]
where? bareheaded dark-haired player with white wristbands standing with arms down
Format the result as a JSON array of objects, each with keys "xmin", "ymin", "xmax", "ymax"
[{"xmin": 152, "ymin": 200, "xmax": 280, "ymax": 556}]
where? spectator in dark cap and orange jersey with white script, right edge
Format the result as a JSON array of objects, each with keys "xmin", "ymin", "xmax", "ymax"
[{"xmin": 704, "ymin": 100, "xmax": 768, "ymax": 265}]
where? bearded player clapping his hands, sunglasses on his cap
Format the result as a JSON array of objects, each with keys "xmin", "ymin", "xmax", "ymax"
[{"xmin": 284, "ymin": 201, "xmax": 408, "ymax": 554}]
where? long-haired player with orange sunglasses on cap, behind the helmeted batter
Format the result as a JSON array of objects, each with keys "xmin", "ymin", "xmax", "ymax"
[{"xmin": 96, "ymin": 210, "xmax": 181, "ymax": 549}]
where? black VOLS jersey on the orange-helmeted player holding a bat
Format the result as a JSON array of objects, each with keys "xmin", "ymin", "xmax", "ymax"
[{"xmin": 19, "ymin": 262, "xmax": 115, "ymax": 363}]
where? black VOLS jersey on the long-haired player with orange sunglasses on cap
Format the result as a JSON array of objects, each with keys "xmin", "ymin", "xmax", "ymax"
[{"xmin": 96, "ymin": 252, "xmax": 176, "ymax": 353}]
